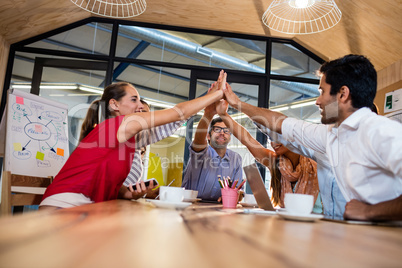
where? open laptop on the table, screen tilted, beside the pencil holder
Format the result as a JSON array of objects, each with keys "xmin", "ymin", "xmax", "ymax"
[{"xmin": 243, "ymin": 163, "xmax": 276, "ymax": 215}]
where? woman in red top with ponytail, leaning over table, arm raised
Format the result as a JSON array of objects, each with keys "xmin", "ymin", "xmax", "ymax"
[{"xmin": 40, "ymin": 71, "xmax": 226, "ymax": 209}]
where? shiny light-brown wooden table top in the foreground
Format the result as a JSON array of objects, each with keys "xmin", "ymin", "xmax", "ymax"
[{"xmin": 0, "ymin": 200, "xmax": 402, "ymax": 268}]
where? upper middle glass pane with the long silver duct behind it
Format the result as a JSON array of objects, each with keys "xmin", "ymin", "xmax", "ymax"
[{"xmin": 116, "ymin": 25, "xmax": 266, "ymax": 73}]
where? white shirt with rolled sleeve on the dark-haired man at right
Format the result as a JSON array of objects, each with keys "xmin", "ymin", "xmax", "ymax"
[{"xmin": 282, "ymin": 108, "xmax": 402, "ymax": 204}]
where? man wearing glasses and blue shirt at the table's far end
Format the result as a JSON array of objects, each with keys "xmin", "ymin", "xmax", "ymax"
[{"xmin": 182, "ymin": 88, "xmax": 243, "ymax": 201}]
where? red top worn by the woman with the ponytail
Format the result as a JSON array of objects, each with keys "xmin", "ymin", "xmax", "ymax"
[{"xmin": 42, "ymin": 116, "xmax": 135, "ymax": 202}]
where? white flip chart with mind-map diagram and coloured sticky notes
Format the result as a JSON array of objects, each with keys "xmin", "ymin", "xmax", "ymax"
[{"xmin": 4, "ymin": 89, "xmax": 69, "ymax": 177}]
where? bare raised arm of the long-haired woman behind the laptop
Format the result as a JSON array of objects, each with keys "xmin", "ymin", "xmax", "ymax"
[{"xmin": 216, "ymin": 97, "xmax": 276, "ymax": 167}]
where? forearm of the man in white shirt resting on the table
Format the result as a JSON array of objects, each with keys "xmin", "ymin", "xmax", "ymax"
[{"xmin": 343, "ymin": 195, "xmax": 402, "ymax": 221}]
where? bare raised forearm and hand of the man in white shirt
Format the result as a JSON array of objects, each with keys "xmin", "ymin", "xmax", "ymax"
[{"xmin": 223, "ymin": 84, "xmax": 286, "ymax": 134}]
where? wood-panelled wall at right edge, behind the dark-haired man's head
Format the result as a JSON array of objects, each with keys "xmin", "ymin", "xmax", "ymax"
[{"xmin": 374, "ymin": 59, "xmax": 402, "ymax": 115}]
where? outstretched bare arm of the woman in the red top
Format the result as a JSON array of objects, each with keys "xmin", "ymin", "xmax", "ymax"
[{"xmin": 117, "ymin": 71, "xmax": 226, "ymax": 142}]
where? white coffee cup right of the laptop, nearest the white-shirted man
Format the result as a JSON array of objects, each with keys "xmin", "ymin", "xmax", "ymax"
[{"xmin": 285, "ymin": 193, "xmax": 314, "ymax": 215}]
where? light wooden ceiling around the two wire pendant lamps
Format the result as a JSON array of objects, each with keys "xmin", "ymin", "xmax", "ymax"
[{"xmin": 0, "ymin": 0, "xmax": 402, "ymax": 70}]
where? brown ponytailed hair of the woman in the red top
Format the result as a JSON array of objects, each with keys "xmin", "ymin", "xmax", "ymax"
[{"xmin": 80, "ymin": 82, "xmax": 134, "ymax": 141}]
